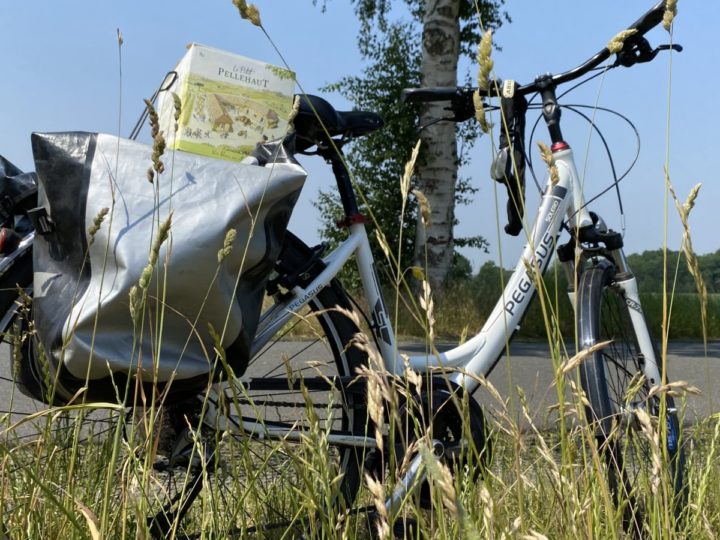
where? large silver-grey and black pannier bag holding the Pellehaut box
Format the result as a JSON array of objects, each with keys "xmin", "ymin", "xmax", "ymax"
[{"xmin": 29, "ymin": 132, "xmax": 306, "ymax": 403}]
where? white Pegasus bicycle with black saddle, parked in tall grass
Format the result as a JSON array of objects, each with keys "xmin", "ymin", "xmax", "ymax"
[{"xmin": 0, "ymin": 0, "xmax": 686, "ymax": 536}]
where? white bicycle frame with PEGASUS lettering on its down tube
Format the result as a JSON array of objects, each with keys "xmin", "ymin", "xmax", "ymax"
[{"xmin": 206, "ymin": 142, "xmax": 660, "ymax": 448}]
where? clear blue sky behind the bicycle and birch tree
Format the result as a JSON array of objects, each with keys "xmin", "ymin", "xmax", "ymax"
[{"xmin": 0, "ymin": 0, "xmax": 720, "ymax": 267}]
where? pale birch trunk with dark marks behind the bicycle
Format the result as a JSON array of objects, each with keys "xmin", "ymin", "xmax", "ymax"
[{"xmin": 415, "ymin": 0, "xmax": 460, "ymax": 291}]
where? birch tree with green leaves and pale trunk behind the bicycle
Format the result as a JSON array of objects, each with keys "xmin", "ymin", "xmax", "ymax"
[{"xmin": 321, "ymin": 0, "xmax": 507, "ymax": 289}]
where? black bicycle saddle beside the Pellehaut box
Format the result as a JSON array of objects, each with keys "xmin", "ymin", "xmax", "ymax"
[{"xmin": 294, "ymin": 94, "xmax": 384, "ymax": 151}]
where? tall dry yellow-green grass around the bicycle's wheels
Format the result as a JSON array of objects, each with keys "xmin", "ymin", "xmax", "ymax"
[{"xmin": 0, "ymin": 1, "xmax": 720, "ymax": 539}]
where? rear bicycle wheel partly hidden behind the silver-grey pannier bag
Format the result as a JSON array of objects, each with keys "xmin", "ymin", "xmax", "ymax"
[{"xmin": 0, "ymin": 234, "xmax": 366, "ymax": 538}]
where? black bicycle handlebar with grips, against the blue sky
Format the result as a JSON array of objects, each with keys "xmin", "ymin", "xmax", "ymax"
[{"xmin": 401, "ymin": 0, "xmax": 666, "ymax": 103}]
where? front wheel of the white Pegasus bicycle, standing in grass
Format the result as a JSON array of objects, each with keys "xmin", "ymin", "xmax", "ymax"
[{"xmin": 576, "ymin": 264, "xmax": 686, "ymax": 537}]
